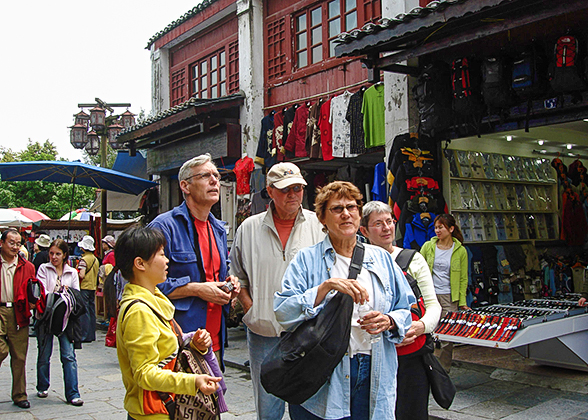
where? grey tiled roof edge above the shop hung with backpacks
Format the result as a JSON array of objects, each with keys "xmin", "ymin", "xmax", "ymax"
[{"xmin": 335, "ymin": 0, "xmax": 506, "ymax": 56}]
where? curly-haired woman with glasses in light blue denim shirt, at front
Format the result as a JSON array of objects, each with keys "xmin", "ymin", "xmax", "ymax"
[{"xmin": 274, "ymin": 181, "xmax": 415, "ymax": 420}]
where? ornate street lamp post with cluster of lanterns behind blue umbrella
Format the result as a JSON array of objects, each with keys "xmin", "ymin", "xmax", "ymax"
[{"xmin": 70, "ymin": 98, "xmax": 135, "ymax": 254}]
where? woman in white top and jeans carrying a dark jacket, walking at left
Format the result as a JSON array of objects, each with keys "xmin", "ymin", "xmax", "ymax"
[{"xmin": 37, "ymin": 239, "xmax": 84, "ymax": 407}]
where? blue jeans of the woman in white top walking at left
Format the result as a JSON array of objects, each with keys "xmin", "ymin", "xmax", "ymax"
[{"xmin": 37, "ymin": 328, "xmax": 80, "ymax": 401}]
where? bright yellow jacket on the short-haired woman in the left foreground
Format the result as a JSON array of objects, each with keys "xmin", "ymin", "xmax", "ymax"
[{"xmin": 116, "ymin": 283, "xmax": 196, "ymax": 420}]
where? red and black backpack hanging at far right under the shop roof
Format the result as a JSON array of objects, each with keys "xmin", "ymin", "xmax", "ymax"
[{"xmin": 549, "ymin": 35, "xmax": 586, "ymax": 93}]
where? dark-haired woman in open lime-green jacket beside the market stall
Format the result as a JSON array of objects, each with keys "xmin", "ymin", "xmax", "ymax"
[{"xmin": 420, "ymin": 214, "xmax": 470, "ymax": 372}]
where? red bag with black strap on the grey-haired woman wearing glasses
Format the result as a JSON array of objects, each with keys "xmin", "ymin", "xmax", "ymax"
[{"xmin": 396, "ymin": 249, "xmax": 433, "ymax": 356}]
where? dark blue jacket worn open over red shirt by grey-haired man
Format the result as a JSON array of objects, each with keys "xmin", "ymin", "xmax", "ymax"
[{"xmin": 149, "ymin": 201, "xmax": 229, "ymax": 360}]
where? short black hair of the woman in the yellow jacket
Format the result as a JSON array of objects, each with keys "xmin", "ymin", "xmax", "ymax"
[{"xmin": 114, "ymin": 226, "xmax": 167, "ymax": 280}]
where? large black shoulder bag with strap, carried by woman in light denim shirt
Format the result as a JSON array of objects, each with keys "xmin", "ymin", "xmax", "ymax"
[{"xmin": 261, "ymin": 242, "xmax": 365, "ymax": 404}]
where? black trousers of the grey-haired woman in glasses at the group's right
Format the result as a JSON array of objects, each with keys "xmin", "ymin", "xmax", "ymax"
[{"xmin": 396, "ymin": 354, "xmax": 429, "ymax": 420}]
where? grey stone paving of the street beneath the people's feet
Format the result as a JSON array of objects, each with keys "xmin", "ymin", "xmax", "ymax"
[{"xmin": 0, "ymin": 328, "xmax": 588, "ymax": 420}]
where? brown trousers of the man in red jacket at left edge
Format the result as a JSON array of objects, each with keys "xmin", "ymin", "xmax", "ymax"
[{"xmin": 0, "ymin": 306, "xmax": 29, "ymax": 403}]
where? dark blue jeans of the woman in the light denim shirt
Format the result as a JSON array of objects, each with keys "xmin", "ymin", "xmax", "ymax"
[{"xmin": 288, "ymin": 354, "xmax": 372, "ymax": 420}]
